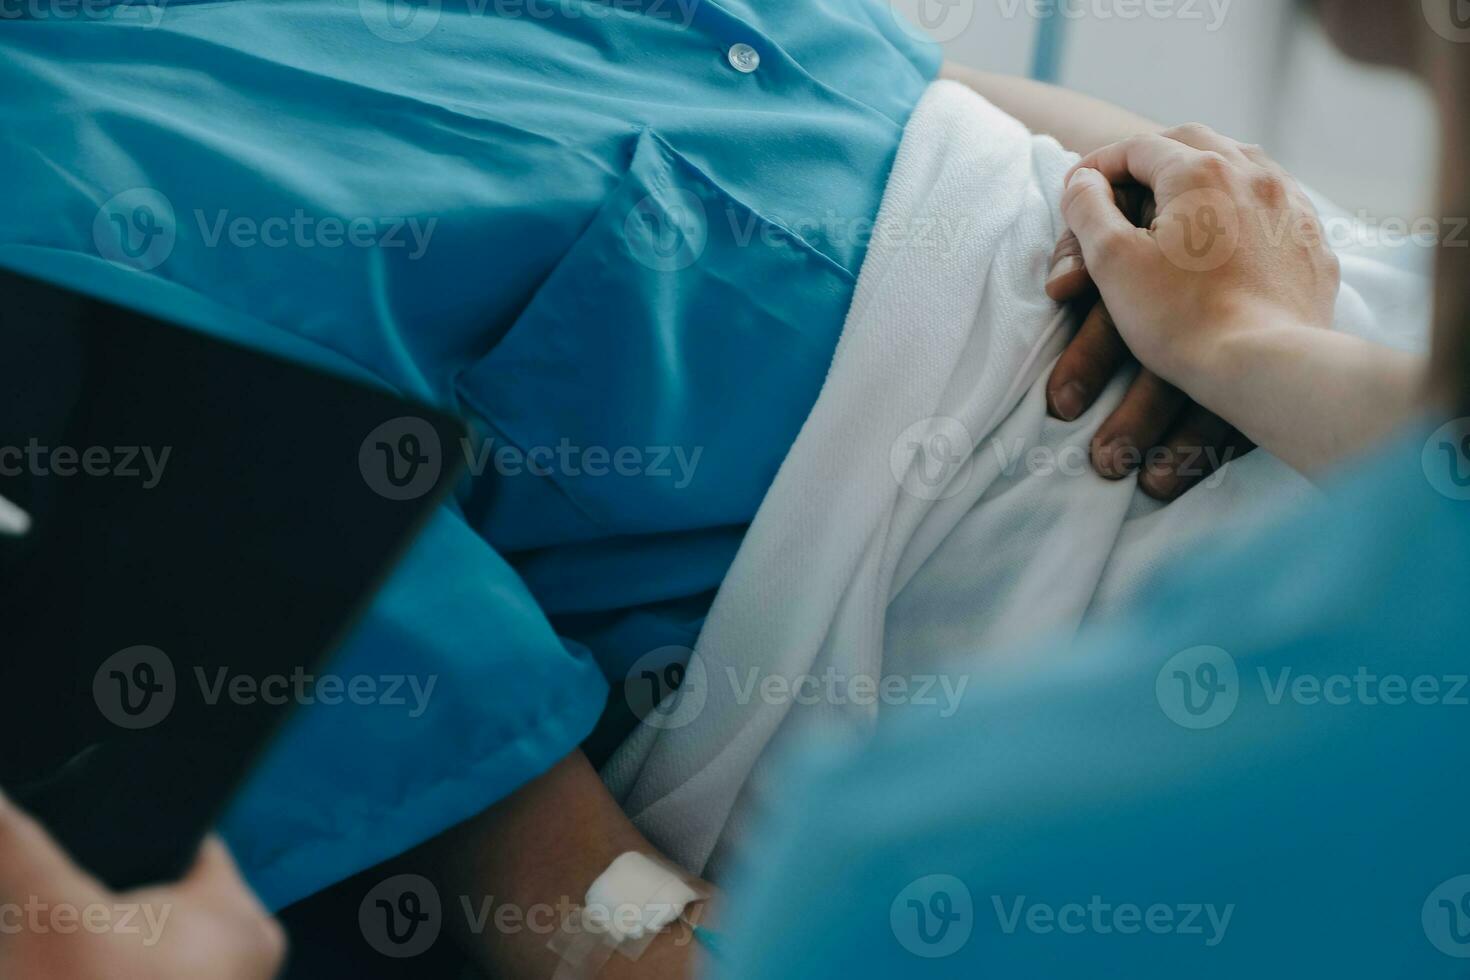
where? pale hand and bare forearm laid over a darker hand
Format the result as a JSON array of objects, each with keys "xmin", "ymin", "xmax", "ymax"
[{"xmin": 1063, "ymin": 125, "xmax": 1424, "ymax": 473}]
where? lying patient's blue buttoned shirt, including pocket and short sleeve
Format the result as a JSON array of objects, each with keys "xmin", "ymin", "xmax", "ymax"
[{"xmin": 0, "ymin": 0, "xmax": 938, "ymax": 905}]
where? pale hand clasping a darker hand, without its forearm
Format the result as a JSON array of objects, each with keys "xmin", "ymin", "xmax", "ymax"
[{"xmin": 1063, "ymin": 125, "xmax": 1341, "ymax": 395}]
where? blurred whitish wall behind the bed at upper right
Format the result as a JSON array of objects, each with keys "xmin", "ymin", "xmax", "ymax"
[{"xmin": 894, "ymin": 0, "xmax": 1438, "ymax": 219}]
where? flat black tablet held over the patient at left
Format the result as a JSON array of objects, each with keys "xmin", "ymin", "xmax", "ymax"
[{"xmin": 0, "ymin": 265, "xmax": 463, "ymax": 887}]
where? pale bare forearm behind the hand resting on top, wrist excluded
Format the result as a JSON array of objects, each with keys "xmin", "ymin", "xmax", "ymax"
[{"xmin": 1176, "ymin": 325, "xmax": 1426, "ymax": 476}]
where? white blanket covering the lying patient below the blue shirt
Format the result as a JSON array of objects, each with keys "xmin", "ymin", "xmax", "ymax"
[{"xmin": 604, "ymin": 82, "xmax": 1427, "ymax": 877}]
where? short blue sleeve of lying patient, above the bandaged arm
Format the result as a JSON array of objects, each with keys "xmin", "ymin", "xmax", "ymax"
[{"xmin": 222, "ymin": 508, "xmax": 606, "ymax": 908}]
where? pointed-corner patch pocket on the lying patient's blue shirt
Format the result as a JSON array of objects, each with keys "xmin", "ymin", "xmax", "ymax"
[{"xmin": 459, "ymin": 132, "xmax": 854, "ymax": 548}]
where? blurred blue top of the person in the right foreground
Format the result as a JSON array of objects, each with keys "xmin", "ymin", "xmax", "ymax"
[{"xmin": 720, "ymin": 420, "xmax": 1470, "ymax": 980}]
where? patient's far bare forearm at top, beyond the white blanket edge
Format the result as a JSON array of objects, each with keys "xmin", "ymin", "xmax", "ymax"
[{"xmin": 939, "ymin": 62, "xmax": 1163, "ymax": 153}]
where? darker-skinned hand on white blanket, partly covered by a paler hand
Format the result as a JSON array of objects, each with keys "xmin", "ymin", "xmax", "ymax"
[{"xmin": 1047, "ymin": 184, "xmax": 1255, "ymax": 501}]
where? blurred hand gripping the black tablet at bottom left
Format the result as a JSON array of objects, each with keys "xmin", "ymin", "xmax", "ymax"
[{"xmin": 0, "ymin": 796, "xmax": 285, "ymax": 980}]
